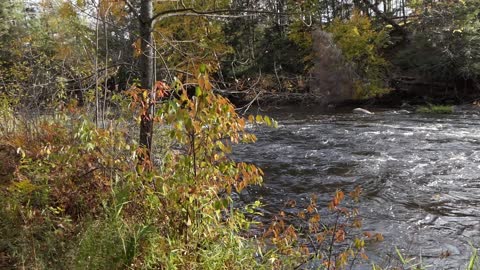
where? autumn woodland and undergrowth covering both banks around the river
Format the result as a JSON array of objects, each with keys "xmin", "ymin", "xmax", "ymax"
[{"xmin": 0, "ymin": 0, "xmax": 480, "ymax": 269}]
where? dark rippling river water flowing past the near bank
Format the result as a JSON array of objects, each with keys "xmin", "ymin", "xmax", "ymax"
[{"xmin": 235, "ymin": 106, "xmax": 480, "ymax": 269}]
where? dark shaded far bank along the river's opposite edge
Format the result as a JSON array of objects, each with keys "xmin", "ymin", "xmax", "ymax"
[{"xmin": 223, "ymin": 75, "xmax": 480, "ymax": 111}]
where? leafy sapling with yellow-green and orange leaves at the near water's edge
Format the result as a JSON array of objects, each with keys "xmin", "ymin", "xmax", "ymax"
[{"xmin": 122, "ymin": 73, "xmax": 278, "ymax": 269}]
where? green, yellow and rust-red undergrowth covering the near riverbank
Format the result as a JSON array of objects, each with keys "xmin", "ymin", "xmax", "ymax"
[{"xmin": 0, "ymin": 70, "xmax": 380, "ymax": 269}]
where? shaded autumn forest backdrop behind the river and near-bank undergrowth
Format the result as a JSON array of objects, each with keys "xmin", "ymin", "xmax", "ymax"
[{"xmin": 0, "ymin": 0, "xmax": 480, "ymax": 113}]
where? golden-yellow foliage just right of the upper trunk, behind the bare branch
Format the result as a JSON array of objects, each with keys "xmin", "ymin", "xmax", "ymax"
[{"xmin": 150, "ymin": 0, "xmax": 233, "ymax": 80}]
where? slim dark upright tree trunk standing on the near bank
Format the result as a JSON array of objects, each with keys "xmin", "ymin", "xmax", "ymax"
[{"xmin": 139, "ymin": 0, "xmax": 155, "ymax": 159}]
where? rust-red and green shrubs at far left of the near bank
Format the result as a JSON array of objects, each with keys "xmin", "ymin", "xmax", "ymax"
[{"xmin": 0, "ymin": 97, "xmax": 133, "ymax": 269}]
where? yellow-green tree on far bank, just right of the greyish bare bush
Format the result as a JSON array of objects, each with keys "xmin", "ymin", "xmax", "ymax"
[{"xmin": 327, "ymin": 11, "xmax": 389, "ymax": 98}]
